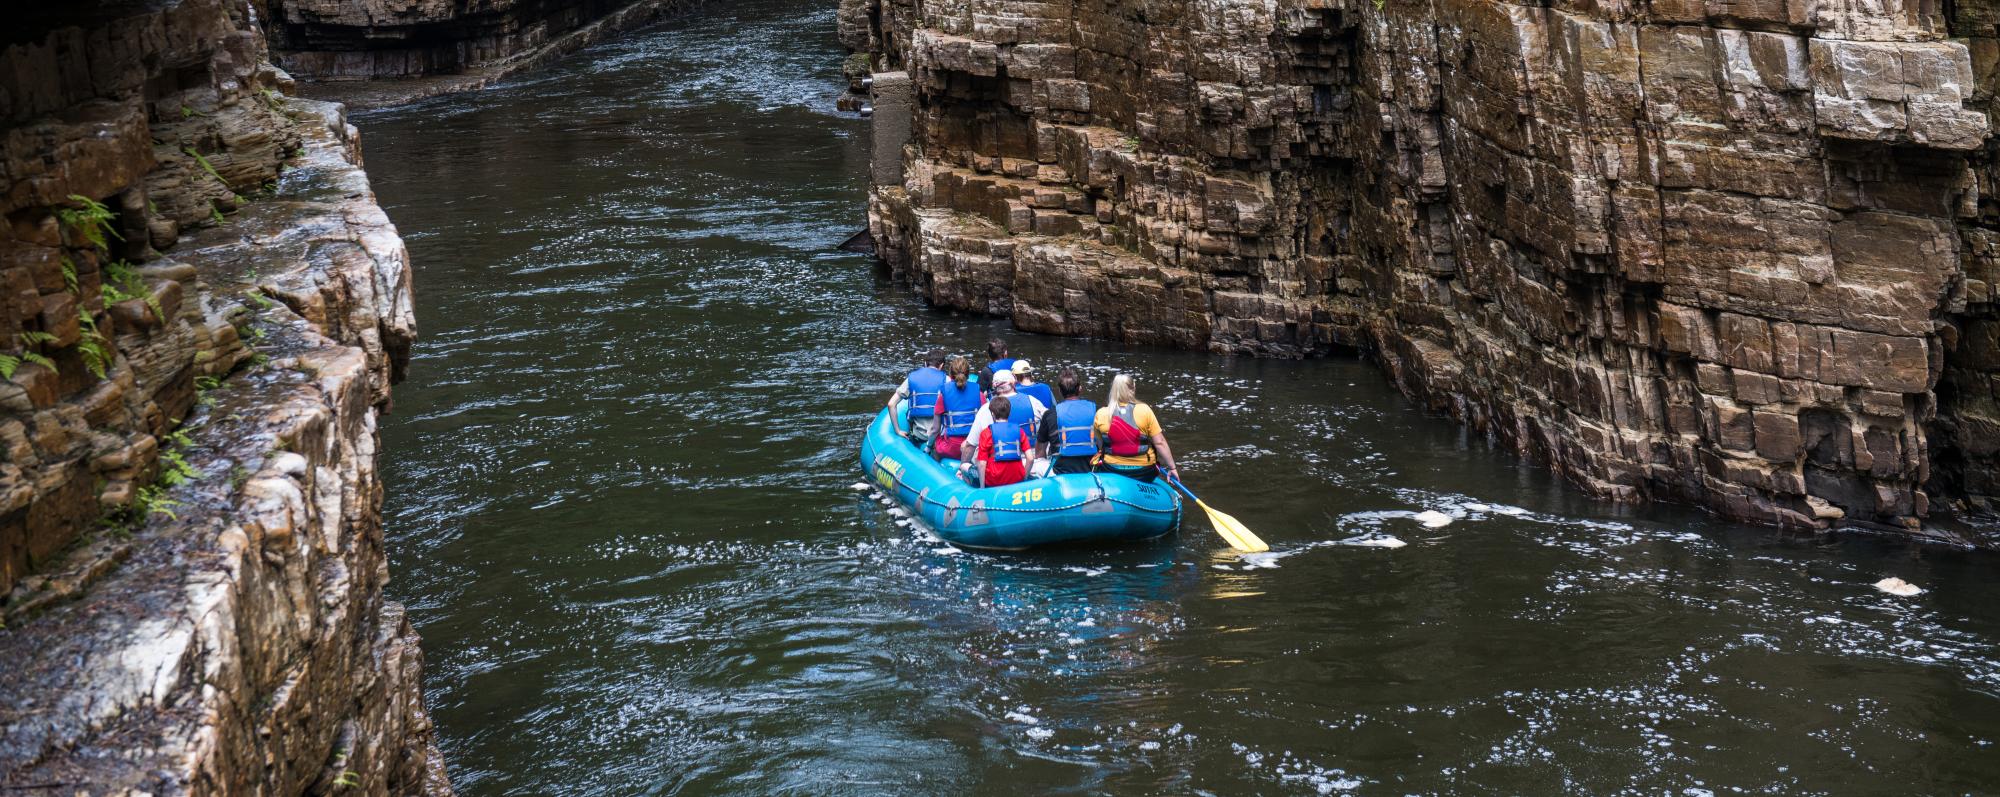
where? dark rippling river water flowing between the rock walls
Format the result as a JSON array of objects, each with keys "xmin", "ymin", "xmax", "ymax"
[{"xmin": 358, "ymin": 0, "xmax": 2000, "ymax": 795}]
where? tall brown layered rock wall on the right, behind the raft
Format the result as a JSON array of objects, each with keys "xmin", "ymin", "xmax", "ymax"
[{"xmin": 840, "ymin": 0, "xmax": 2000, "ymax": 529}]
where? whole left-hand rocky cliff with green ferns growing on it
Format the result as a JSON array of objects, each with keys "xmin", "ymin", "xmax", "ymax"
[{"xmin": 0, "ymin": 0, "xmax": 450, "ymax": 795}]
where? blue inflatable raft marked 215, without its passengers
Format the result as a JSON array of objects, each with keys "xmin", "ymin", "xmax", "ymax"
[{"xmin": 862, "ymin": 411, "xmax": 1180, "ymax": 551}]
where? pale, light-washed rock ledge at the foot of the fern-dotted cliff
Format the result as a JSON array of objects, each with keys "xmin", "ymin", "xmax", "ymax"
[{"xmin": 0, "ymin": 100, "xmax": 450, "ymax": 795}]
